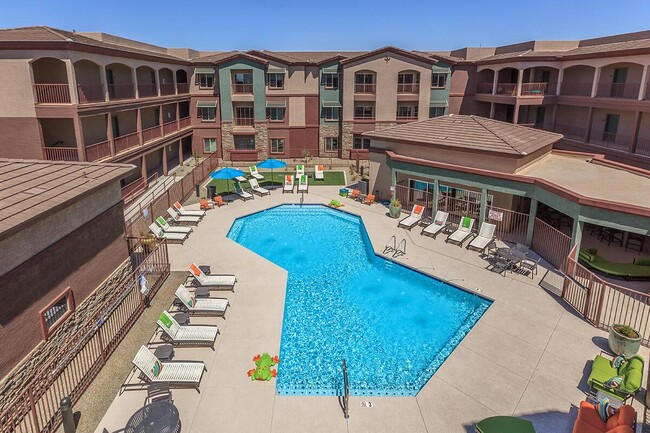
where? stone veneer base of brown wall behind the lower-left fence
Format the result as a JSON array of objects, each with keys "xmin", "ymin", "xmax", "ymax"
[{"xmin": 0, "ymin": 259, "xmax": 133, "ymax": 412}]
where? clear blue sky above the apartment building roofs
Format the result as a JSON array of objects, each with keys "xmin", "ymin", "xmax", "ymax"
[{"xmin": 0, "ymin": 0, "xmax": 650, "ymax": 51}]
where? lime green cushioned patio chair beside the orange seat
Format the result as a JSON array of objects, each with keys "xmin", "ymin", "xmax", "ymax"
[{"xmin": 587, "ymin": 352, "xmax": 645, "ymax": 401}]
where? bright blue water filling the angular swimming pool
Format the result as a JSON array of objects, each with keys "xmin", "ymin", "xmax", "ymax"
[{"xmin": 228, "ymin": 205, "xmax": 490, "ymax": 395}]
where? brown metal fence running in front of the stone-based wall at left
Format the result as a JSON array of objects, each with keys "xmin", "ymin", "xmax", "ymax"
[{"xmin": 0, "ymin": 239, "xmax": 169, "ymax": 433}]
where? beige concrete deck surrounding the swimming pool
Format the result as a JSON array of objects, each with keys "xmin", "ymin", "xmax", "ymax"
[{"xmin": 96, "ymin": 187, "xmax": 650, "ymax": 433}]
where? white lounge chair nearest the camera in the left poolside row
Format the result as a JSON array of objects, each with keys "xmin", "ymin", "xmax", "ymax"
[{"xmin": 132, "ymin": 346, "xmax": 205, "ymax": 392}]
